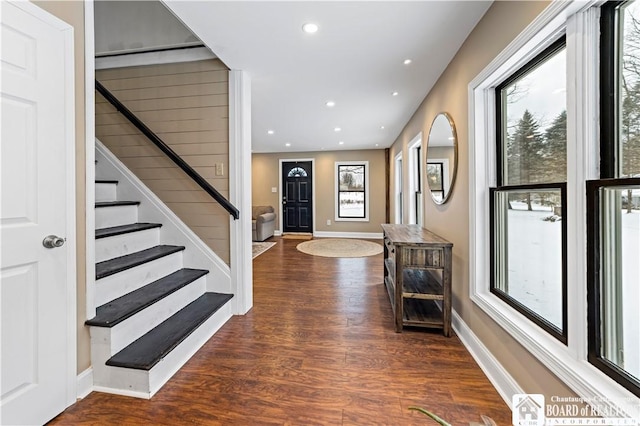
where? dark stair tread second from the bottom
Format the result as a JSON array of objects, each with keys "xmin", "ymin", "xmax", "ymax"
[{"xmin": 85, "ymin": 268, "xmax": 209, "ymax": 327}]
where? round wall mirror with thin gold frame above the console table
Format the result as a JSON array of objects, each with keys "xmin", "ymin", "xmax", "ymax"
[{"xmin": 426, "ymin": 112, "xmax": 458, "ymax": 204}]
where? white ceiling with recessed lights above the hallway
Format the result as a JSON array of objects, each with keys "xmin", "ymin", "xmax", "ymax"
[{"xmin": 156, "ymin": 0, "xmax": 491, "ymax": 152}]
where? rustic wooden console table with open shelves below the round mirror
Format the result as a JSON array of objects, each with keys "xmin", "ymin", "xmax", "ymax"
[{"xmin": 382, "ymin": 224, "xmax": 453, "ymax": 337}]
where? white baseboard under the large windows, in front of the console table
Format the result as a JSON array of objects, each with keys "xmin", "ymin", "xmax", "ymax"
[{"xmin": 451, "ymin": 311, "xmax": 525, "ymax": 409}]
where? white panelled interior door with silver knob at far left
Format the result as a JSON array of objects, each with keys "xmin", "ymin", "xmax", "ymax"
[{"xmin": 0, "ymin": 1, "xmax": 75, "ymax": 425}]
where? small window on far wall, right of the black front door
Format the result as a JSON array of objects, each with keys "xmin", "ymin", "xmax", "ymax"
[{"xmin": 335, "ymin": 161, "xmax": 369, "ymax": 221}]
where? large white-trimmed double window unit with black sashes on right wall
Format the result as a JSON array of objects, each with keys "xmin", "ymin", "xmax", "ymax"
[{"xmin": 468, "ymin": 0, "xmax": 640, "ymax": 412}]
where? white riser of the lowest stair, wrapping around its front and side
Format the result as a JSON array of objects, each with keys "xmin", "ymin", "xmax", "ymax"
[{"xmin": 91, "ymin": 303, "xmax": 233, "ymax": 399}]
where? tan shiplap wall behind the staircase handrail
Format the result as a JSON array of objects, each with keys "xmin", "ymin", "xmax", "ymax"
[{"xmin": 96, "ymin": 59, "xmax": 230, "ymax": 264}]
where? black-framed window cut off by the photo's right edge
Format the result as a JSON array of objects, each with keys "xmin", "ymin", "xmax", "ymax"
[{"xmin": 587, "ymin": 1, "xmax": 640, "ymax": 396}]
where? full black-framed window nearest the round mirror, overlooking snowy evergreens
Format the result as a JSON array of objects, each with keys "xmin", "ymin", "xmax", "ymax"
[{"xmin": 489, "ymin": 38, "xmax": 567, "ymax": 343}]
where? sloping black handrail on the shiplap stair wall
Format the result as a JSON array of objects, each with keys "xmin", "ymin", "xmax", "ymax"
[{"xmin": 96, "ymin": 80, "xmax": 240, "ymax": 219}]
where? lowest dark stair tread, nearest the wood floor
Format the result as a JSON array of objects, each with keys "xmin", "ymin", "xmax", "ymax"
[{"xmin": 106, "ymin": 293, "xmax": 233, "ymax": 371}]
